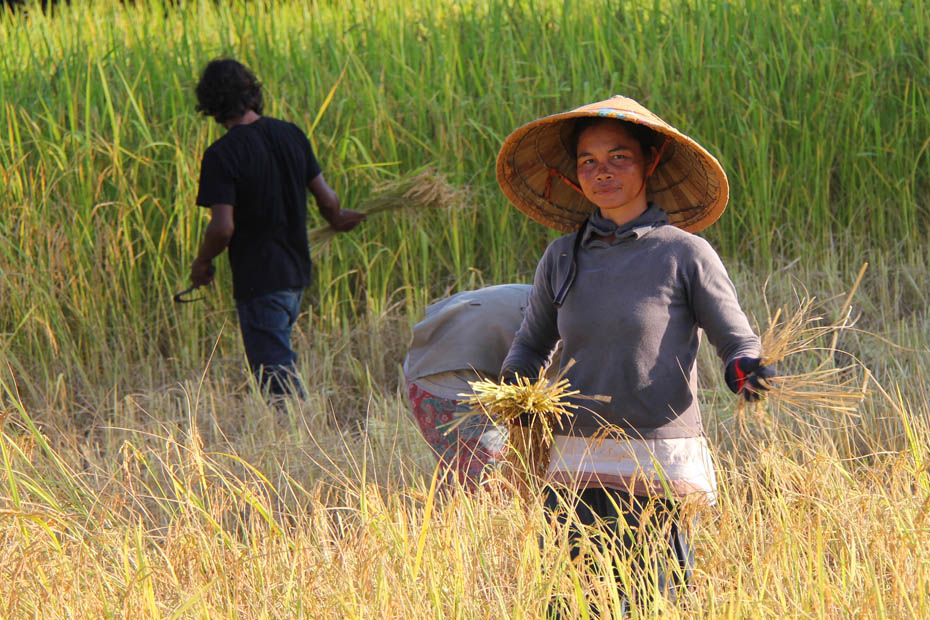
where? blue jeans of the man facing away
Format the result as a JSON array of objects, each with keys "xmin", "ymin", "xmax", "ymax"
[{"xmin": 236, "ymin": 289, "xmax": 304, "ymax": 396}]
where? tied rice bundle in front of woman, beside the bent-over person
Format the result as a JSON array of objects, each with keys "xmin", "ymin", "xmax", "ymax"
[{"xmin": 461, "ymin": 360, "xmax": 610, "ymax": 483}]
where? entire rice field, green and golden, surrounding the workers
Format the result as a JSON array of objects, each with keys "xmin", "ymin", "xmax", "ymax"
[{"xmin": 0, "ymin": 0, "xmax": 930, "ymax": 619}]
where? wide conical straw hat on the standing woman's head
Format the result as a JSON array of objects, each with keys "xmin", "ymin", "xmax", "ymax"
[{"xmin": 497, "ymin": 95, "xmax": 730, "ymax": 233}]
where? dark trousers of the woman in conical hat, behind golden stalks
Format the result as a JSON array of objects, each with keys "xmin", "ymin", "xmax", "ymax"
[{"xmin": 544, "ymin": 487, "xmax": 694, "ymax": 615}]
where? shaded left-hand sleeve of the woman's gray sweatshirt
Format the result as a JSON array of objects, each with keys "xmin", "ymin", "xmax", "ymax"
[{"xmin": 501, "ymin": 245, "xmax": 559, "ymax": 378}]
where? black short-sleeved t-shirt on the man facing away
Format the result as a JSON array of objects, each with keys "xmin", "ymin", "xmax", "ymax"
[{"xmin": 197, "ymin": 117, "xmax": 320, "ymax": 299}]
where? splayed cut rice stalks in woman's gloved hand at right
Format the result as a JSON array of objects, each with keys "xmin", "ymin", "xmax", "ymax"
[{"xmin": 762, "ymin": 263, "xmax": 871, "ymax": 414}]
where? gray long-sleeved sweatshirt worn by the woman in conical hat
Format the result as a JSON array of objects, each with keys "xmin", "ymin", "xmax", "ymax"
[{"xmin": 501, "ymin": 205, "xmax": 760, "ymax": 439}]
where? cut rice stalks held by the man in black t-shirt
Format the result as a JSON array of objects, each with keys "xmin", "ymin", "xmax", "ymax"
[{"xmin": 307, "ymin": 167, "xmax": 472, "ymax": 251}]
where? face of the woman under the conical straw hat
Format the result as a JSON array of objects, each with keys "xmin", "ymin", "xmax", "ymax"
[{"xmin": 577, "ymin": 120, "xmax": 646, "ymax": 212}]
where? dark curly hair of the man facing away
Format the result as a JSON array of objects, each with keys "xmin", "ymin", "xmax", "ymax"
[{"xmin": 196, "ymin": 58, "xmax": 264, "ymax": 123}]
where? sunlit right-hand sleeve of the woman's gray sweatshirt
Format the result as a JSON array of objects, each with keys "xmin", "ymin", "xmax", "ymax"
[{"xmin": 688, "ymin": 237, "xmax": 761, "ymax": 365}]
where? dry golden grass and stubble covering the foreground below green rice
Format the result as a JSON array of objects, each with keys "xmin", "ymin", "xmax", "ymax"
[{"xmin": 0, "ymin": 262, "xmax": 930, "ymax": 620}]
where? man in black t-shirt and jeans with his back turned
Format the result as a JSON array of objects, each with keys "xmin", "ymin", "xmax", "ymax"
[{"xmin": 191, "ymin": 59, "xmax": 365, "ymax": 394}]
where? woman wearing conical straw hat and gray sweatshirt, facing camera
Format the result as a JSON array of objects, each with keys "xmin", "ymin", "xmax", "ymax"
[{"xmin": 497, "ymin": 97, "xmax": 774, "ymax": 612}]
